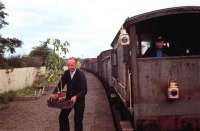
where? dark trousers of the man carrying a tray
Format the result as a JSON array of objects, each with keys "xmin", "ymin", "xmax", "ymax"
[{"xmin": 59, "ymin": 99, "xmax": 85, "ymax": 131}]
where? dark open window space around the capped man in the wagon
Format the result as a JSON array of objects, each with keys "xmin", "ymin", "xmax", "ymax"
[{"xmin": 136, "ymin": 13, "xmax": 200, "ymax": 57}]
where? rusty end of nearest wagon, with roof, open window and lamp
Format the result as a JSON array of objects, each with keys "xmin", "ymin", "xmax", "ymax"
[{"xmin": 116, "ymin": 6, "xmax": 200, "ymax": 131}]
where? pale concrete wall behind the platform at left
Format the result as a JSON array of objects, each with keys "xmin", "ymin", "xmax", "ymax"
[{"xmin": 0, "ymin": 67, "xmax": 45, "ymax": 93}]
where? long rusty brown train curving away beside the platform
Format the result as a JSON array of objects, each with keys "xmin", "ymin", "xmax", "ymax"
[{"xmin": 82, "ymin": 6, "xmax": 200, "ymax": 131}]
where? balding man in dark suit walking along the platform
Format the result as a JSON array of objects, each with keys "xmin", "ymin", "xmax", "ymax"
[{"xmin": 50, "ymin": 57, "xmax": 87, "ymax": 131}]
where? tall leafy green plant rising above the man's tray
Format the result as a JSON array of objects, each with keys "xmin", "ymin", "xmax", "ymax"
[{"xmin": 43, "ymin": 38, "xmax": 69, "ymax": 83}]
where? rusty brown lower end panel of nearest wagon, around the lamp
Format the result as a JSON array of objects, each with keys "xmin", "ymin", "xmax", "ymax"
[{"xmin": 134, "ymin": 56, "xmax": 200, "ymax": 130}]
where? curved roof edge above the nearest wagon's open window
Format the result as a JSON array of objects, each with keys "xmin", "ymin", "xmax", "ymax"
[{"xmin": 124, "ymin": 6, "xmax": 200, "ymax": 25}]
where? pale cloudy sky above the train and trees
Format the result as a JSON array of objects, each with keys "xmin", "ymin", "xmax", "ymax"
[{"xmin": 0, "ymin": 0, "xmax": 200, "ymax": 58}]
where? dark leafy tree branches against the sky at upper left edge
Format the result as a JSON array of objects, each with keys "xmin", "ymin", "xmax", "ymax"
[{"xmin": 0, "ymin": 2, "xmax": 22, "ymax": 61}]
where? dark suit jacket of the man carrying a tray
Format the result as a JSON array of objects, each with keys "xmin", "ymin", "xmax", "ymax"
[{"xmin": 54, "ymin": 69, "xmax": 87, "ymax": 100}]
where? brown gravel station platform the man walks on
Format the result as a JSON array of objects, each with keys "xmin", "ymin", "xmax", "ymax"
[{"xmin": 0, "ymin": 72, "xmax": 116, "ymax": 131}]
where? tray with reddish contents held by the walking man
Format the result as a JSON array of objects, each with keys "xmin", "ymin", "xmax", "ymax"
[{"xmin": 47, "ymin": 92, "xmax": 73, "ymax": 109}]
